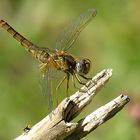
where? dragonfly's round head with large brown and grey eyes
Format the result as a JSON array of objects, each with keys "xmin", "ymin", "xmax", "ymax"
[{"xmin": 75, "ymin": 58, "xmax": 91, "ymax": 75}]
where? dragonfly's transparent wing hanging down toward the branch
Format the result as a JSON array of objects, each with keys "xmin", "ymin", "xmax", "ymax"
[{"xmin": 39, "ymin": 69, "xmax": 53, "ymax": 113}]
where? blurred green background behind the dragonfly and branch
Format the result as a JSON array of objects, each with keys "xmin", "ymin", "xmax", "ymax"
[{"xmin": 0, "ymin": 0, "xmax": 140, "ymax": 140}]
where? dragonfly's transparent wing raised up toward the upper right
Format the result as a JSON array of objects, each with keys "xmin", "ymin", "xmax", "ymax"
[{"xmin": 56, "ymin": 9, "xmax": 96, "ymax": 51}]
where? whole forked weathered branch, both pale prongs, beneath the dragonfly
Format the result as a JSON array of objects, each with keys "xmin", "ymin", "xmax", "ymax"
[{"xmin": 16, "ymin": 69, "xmax": 129, "ymax": 140}]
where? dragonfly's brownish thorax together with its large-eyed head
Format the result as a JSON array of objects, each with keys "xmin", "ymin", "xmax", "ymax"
[{"xmin": 51, "ymin": 51, "xmax": 91, "ymax": 75}]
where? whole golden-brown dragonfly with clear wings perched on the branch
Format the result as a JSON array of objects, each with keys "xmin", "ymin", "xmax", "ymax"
[{"xmin": 0, "ymin": 9, "xmax": 97, "ymax": 110}]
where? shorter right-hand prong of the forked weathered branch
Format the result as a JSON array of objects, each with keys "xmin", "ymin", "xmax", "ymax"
[{"xmin": 66, "ymin": 95, "xmax": 129, "ymax": 140}]
